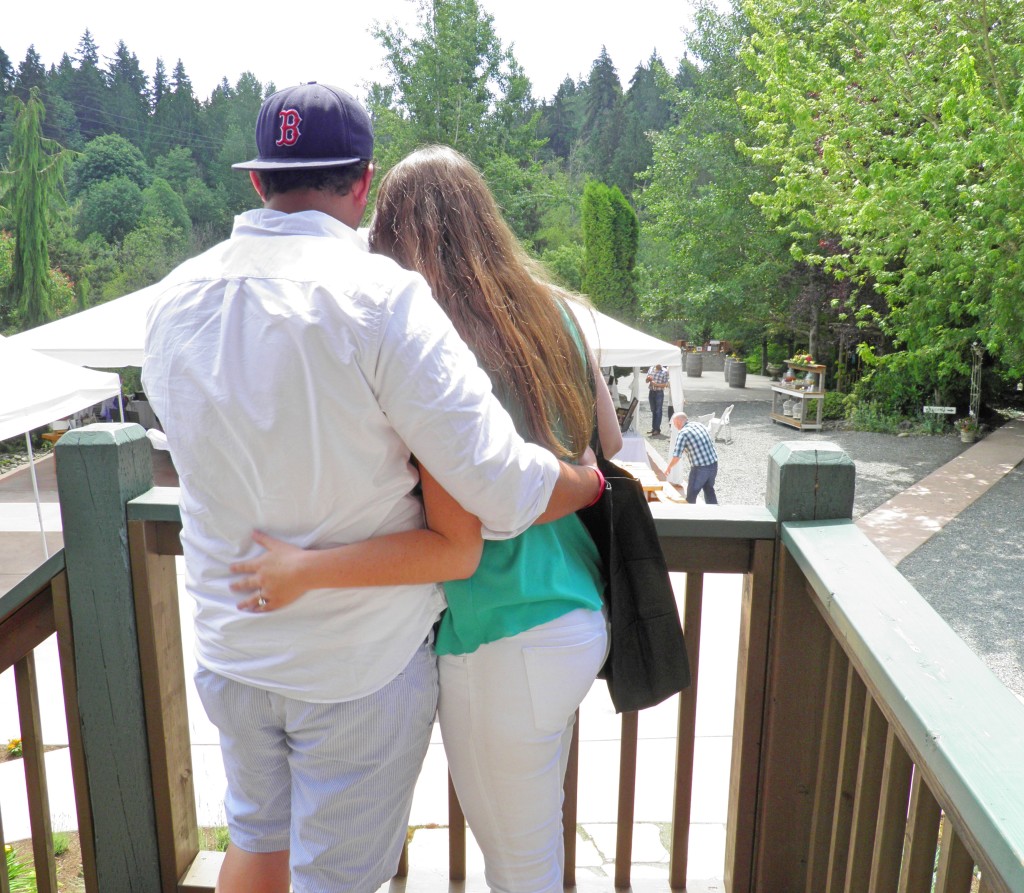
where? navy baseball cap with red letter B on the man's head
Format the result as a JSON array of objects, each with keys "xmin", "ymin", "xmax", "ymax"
[{"xmin": 231, "ymin": 81, "xmax": 374, "ymax": 171}]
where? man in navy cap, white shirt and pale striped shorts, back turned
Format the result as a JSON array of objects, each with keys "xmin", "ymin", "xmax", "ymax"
[{"xmin": 142, "ymin": 83, "xmax": 600, "ymax": 893}]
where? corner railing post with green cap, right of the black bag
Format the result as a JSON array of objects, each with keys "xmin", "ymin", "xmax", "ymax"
[{"xmin": 749, "ymin": 440, "xmax": 855, "ymax": 890}]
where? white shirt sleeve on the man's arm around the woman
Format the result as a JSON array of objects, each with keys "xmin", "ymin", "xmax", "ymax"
[{"xmin": 375, "ymin": 277, "xmax": 559, "ymax": 540}]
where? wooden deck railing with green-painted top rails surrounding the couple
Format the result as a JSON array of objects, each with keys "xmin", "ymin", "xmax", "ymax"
[{"xmin": 0, "ymin": 426, "xmax": 1024, "ymax": 893}]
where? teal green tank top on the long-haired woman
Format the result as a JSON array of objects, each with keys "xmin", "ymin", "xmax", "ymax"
[{"xmin": 434, "ymin": 303, "xmax": 604, "ymax": 654}]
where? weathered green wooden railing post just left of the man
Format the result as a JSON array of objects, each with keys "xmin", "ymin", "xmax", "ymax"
[{"xmin": 55, "ymin": 424, "xmax": 161, "ymax": 893}]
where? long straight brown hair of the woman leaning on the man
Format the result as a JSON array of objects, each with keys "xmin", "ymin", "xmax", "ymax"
[{"xmin": 370, "ymin": 145, "xmax": 594, "ymax": 458}]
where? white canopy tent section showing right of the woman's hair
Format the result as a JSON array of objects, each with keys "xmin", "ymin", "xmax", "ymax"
[{"xmin": 571, "ymin": 303, "xmax": 683, "ymax": 417}]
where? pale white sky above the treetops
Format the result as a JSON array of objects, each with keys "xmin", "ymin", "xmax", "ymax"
[{"xmin": 0, "ymin": 0, "xmax": 729, "ymax": 99}]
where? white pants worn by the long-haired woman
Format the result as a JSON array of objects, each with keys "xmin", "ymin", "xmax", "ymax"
[{"xmin": 438, "ymin": 609, "xmax": 608, "ymax": 893}]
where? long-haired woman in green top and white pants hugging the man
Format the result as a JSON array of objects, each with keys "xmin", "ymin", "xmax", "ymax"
[{"xmin": 234, "ymin": 146, "xmax": 622, "ymax": 893}]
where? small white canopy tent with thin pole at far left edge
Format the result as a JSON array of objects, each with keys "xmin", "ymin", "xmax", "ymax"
[{"xmin": 0, "ymin": 336, "xmax": 121, "ymax": 554}]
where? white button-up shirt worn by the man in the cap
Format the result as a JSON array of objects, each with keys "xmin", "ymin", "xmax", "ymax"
[{"xmin": 142, "ymin": 210, "xmax": 558, "ymax": 701}]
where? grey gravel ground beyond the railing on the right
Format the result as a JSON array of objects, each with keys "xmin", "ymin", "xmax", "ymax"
[{"xmin": 638, "ymin": 393, "xmax": 1024, "ymax": 700}]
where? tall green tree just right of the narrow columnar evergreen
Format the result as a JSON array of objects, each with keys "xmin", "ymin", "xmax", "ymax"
[{"xmin": 639, "ymin": 2, "xmax": 796, "ymax": 341}]
